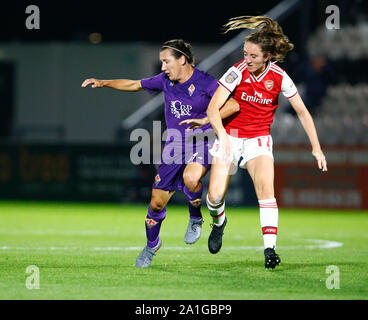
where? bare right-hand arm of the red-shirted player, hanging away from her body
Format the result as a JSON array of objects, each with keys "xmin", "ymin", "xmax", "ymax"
[{"xmin": 289, "ymin": 93, "xmax": 327, "ymax": 171}]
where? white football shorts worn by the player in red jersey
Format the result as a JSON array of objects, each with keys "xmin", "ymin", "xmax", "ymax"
[{"xmin": 210, "ymin": 134, "xmax": 273, "ymax": 169}]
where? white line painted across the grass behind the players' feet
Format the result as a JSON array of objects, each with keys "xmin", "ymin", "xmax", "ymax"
[{"xmin": 0, "ymin": 239, "xmax": 343, "ymax": 251}]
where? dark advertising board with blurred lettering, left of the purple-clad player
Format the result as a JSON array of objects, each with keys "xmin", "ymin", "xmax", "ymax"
[{"xmin": 0, "ymin": 144, "xmax": 154, "ymax": 202}]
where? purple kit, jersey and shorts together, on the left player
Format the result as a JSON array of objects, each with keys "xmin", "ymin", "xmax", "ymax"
[{"xmin": 141, "ymin": 68, "xmax": 218, "ymax": 190}]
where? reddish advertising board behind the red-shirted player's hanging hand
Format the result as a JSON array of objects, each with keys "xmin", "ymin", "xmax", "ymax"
[{"xmin": 274, "ymin": 147, "xmax": 368, "ymax": 209}]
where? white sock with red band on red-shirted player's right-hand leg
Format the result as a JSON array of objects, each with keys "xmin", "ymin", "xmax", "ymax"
[{"xmin": 258, "ymin": 198, "xmax": 279, "ymax": 249}]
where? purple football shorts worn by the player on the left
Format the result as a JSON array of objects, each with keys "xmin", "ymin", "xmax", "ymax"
[{"xmin": 152, "ymin": 131, "xmax": 213, "ymax": 191}]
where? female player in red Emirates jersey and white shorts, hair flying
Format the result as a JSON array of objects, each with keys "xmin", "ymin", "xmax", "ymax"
[{"xmin": 207, "ymin": 16, "xmax": 327, "ymax": 269}]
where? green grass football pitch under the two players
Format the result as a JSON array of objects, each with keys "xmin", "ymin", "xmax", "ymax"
[{"xmin": 0, "ymin": 201, "xmax": 368, "ymax": 300}]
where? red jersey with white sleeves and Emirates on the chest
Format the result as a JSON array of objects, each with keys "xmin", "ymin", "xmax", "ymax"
[{"xmin": 218, "ymin": 60, "xmax": 298, "ymax": 138}]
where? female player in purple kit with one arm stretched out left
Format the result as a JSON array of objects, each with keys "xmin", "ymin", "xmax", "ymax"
[{"xmin": 82, "ymin": 39, "xmax": 239, "ymax": 267}]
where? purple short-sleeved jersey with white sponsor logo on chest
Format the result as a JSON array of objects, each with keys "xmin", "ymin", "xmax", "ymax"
[{"xmin": 141, "ymin": 68, "xmax": 218, "ymax": 139}]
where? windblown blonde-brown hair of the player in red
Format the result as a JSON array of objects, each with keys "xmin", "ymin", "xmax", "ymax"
[{"xmin": 223, "ymin": 16, "xmax": 294, "ymax": 62}]
